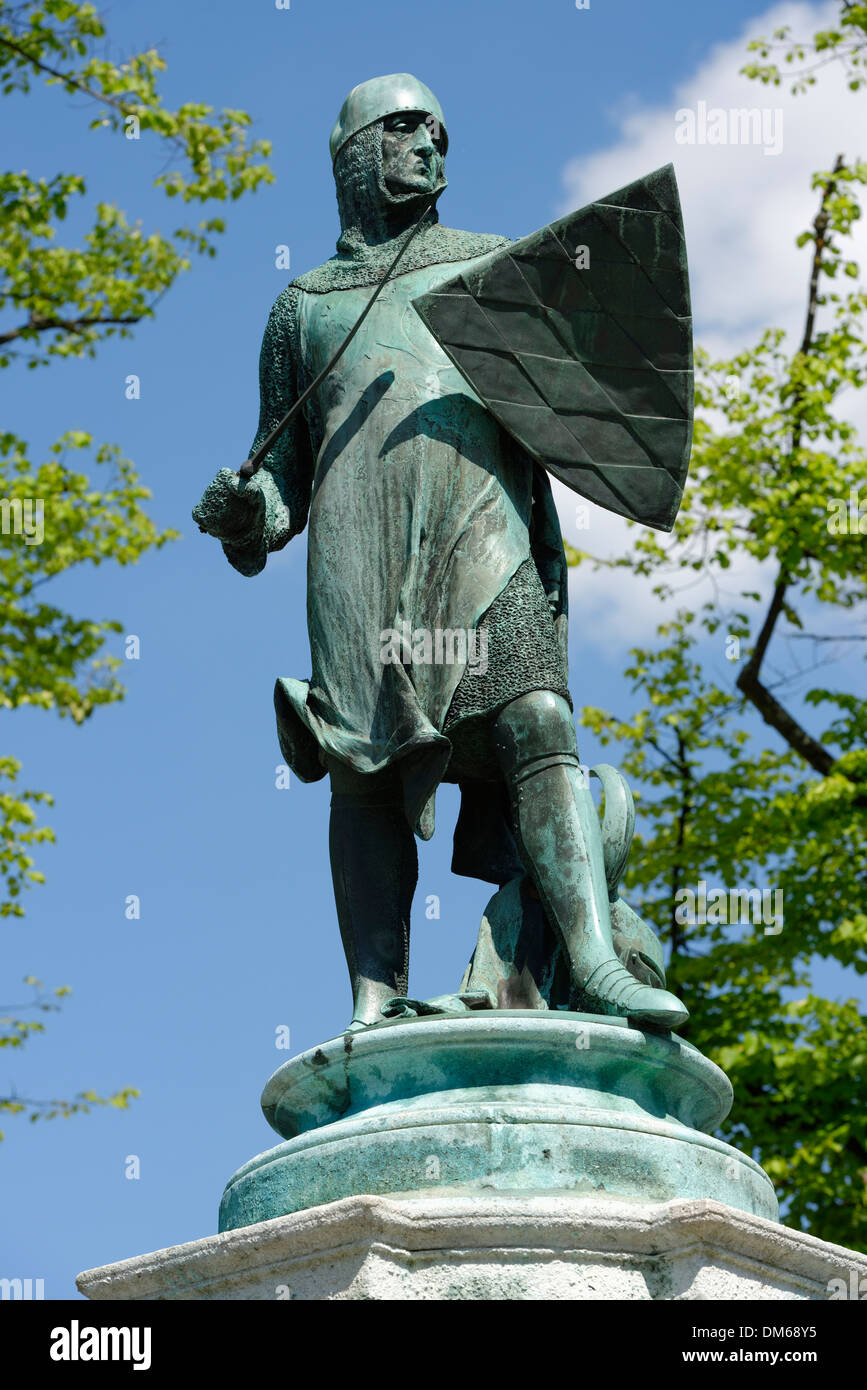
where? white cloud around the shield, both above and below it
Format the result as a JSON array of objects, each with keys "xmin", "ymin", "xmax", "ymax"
[{"xmin": 554, "ymin": 3, "xmax": 867, "ymax": 649}]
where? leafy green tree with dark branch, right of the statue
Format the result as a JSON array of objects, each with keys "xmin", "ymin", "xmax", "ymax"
[{"xmin": 572, "ymin": 6, "xmax": 867, "ymax": 1250}]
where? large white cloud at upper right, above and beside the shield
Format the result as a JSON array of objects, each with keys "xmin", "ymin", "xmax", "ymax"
[{"xmin": 563, "ymin": 4, "xmax": 867, "ymax": 348}]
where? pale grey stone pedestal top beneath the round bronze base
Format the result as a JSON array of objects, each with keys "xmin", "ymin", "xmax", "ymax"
[{"xmin": 78, "ymin": 1194, "xmax": 867, "ymax": 1300}]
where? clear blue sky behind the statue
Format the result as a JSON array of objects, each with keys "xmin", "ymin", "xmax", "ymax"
[{"xmin": 0, "ymin": 0, "xmax": 856, "ymax": 1298}]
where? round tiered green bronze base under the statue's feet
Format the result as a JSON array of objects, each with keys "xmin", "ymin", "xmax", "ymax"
[{"xmin": 220, "ymin": 1011, "xmax": 777, "ymax": 1230}]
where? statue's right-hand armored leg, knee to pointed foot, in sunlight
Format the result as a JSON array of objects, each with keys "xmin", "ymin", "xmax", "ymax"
[{"xmin": 493, "ymin": 691, "xmax": 689, "ymax": 1027}]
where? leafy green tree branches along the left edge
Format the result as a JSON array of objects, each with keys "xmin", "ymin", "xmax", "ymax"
[{"xmin": 0, "ymin": 0, "xmax": 272, "ymax": 1137}]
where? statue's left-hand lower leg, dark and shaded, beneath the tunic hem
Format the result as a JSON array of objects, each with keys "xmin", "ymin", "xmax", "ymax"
[{"xmin": 329, "ymin": 763, "xmax": 418, "ymax": 1027}]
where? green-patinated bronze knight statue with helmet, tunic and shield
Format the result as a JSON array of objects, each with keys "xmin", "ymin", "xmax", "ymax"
[{"xmin": 193, "ymin": 74, "xmax": 692, "ymax": 1029}]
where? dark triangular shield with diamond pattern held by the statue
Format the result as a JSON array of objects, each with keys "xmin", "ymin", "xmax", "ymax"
[{"xmin": 413, "ymin": 164, "xmax": 693, "ymax": 531}]
